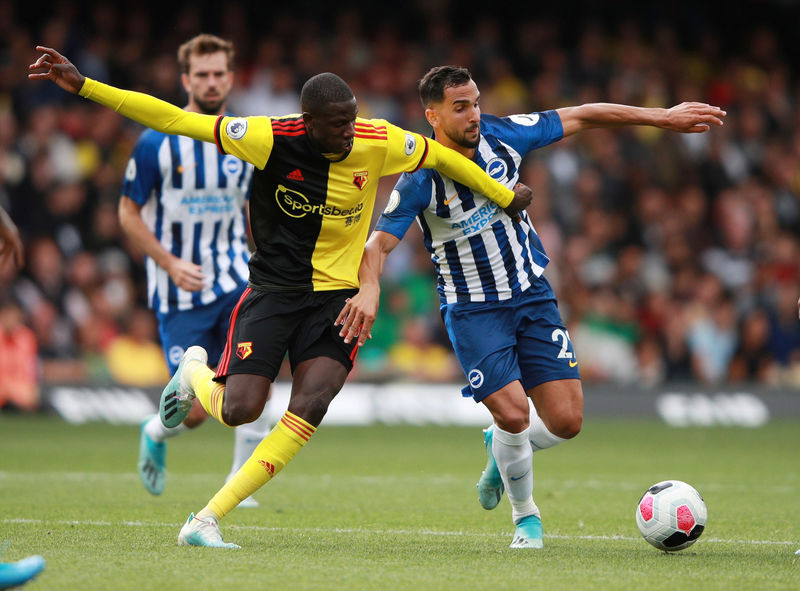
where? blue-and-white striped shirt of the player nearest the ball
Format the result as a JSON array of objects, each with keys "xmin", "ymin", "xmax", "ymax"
[{"xmin": 375, "ymin": 111, "xmax": 564, "ymax": 304}]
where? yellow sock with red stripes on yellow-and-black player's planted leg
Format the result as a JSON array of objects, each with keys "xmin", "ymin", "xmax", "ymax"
[{"xmin": 197, "ymin": 411, "xmax": 316, "ymax": 519}]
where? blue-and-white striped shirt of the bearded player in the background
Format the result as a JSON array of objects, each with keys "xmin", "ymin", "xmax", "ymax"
[{"xmin": 122, "ymin": 130, "xmax": 253, "ymax": 313}]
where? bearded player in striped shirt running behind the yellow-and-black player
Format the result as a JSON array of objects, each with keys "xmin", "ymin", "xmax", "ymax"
[{"xmin": 119, "ymin": 35, "xmax": 269, "ymax": 507}]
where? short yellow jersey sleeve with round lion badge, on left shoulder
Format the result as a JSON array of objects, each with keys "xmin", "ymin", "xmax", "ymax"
[{"xmin": 214, "ymin": 116, "xmax": 274, "ymax": 170}]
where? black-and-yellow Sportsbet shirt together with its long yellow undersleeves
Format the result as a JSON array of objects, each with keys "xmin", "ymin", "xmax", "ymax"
[{"xmin": 80, "ymin": 78, "xmax": 514, "ymax": 291}]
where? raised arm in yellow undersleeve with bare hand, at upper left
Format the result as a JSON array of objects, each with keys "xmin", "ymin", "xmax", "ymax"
[{"xmin": 28, "ymin": 46, "xmax": 217, "ymax": 143}]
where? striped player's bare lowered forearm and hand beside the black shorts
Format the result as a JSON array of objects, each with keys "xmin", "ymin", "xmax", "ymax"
[{"xmin": 334, "ymin": 230, "xmax": 400, "ymax": 347}]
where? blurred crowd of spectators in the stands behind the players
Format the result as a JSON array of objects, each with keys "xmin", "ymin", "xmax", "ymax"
[{"xmin": 0, "ymin": 0, "xmax": 800, "ymax": 407}]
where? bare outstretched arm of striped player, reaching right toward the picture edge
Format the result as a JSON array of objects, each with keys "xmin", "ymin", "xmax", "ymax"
[{"xmin": 556, "ymin": 103, "xmax": 726, "ymax": 137}]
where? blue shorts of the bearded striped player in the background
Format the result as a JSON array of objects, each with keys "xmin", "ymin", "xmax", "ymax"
[{"xmin": 156, "ymin": 283, "xmax": 247, "ymax": 374}]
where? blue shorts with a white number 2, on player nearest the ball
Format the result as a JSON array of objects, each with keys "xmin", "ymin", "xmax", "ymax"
[{"xmin": 441, "ymin": 277, "xmax": 580, "ymax": 402}]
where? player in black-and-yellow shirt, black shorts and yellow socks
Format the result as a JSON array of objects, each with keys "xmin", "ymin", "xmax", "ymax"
[{"xmin": 29, "ymin": 47, "xmax": 531, "ymax": 548}]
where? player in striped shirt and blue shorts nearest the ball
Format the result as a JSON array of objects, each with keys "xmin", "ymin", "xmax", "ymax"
[{"xmin": 337, "ymin": 66, "xmax": 725, "ymax": 548}]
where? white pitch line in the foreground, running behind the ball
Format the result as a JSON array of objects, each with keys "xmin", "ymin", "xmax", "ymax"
[{"xmin": 0, "ymin": 518, "xmax": 797, "ymax": 546}]
